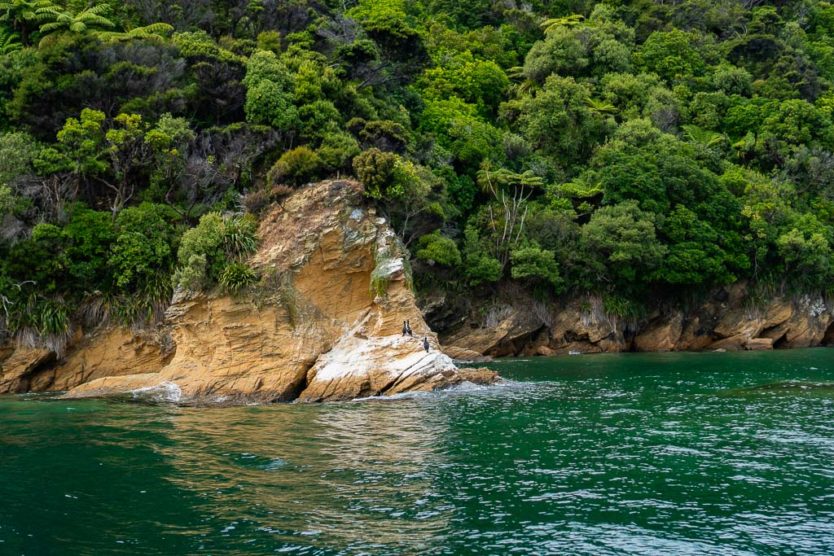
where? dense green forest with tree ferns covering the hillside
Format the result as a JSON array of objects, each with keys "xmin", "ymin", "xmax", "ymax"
[{"xmin": 0, "ymin": 0, "xmax": 834, "ymax": 347}]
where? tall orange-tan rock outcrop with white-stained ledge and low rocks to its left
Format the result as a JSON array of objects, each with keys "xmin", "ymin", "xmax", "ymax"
[{"xmin": 0, "ymin": 181, "xmax": 497, "ymax": 403}]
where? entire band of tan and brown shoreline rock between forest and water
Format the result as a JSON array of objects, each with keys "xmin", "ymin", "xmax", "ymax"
[{"xmin": 0, "ymin": 180, "xmax": 834, "ymax": 404}]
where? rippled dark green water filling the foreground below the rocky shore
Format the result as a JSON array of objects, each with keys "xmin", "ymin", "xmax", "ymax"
[{"xmin": 0, "ymin": 349, "xmax": 834, "ymax": 555}]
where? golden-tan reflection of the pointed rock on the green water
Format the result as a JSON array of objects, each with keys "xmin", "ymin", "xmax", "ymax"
[{"xmin": 157, "ymin": 401, "xmax": 449, "ymax": 550}]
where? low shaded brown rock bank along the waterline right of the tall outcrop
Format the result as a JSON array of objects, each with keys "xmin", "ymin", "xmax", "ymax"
[{"xmin": 436, "ymin": 283, "xmax": 834, "ymax": 359}]
